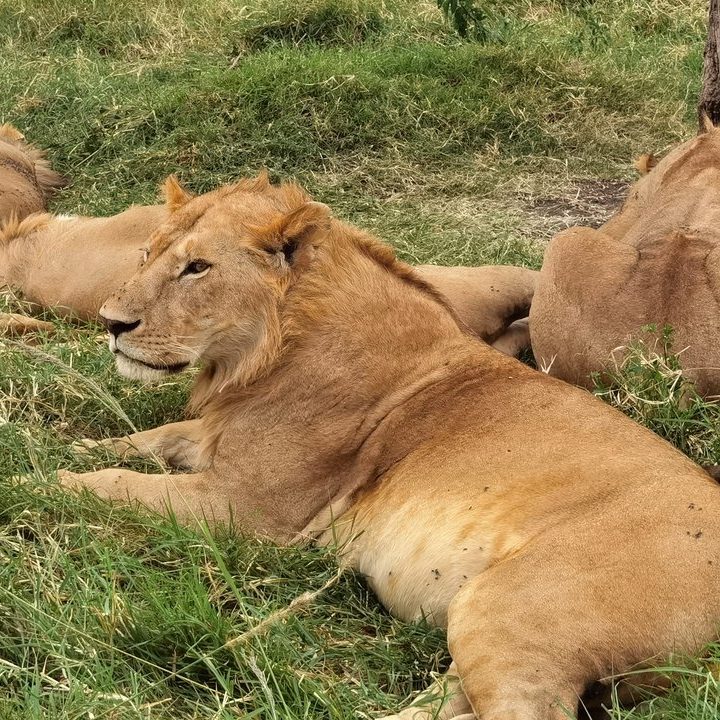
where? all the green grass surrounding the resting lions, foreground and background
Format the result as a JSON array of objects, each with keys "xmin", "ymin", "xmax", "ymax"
[{"xmin": 0, "ymin": 0, "xmax": 720, "ymax": 720}]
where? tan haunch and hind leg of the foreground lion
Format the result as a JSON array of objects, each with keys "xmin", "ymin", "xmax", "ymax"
[{"xmin": 448, "ymin": 516, "xmax": 720, "ymax": 720}]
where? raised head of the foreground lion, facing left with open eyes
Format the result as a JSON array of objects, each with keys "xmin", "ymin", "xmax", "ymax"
[{"xmin": 100, "ymin": 175, "xmax": 330, "ymax": 402}]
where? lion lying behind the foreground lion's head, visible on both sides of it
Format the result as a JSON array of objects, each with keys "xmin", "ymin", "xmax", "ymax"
[{"xmin": 0, "ymin": 180, "xmax": 538, "ymax": 355}]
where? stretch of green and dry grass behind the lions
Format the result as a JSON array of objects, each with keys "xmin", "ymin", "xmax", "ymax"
[{"xmin": 0, "ymin": 0, "xmax": 704, "ymax": 265}]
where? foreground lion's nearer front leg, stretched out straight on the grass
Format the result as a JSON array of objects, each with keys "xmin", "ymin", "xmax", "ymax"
[{"xmin": 58, "ymin": 468, "xmax": 231, "ymax": 522}]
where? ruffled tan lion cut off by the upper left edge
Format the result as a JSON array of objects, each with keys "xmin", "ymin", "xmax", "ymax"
[{"xmin": 0, "ymin": 124, "xmax": 66, "ymax": 223}]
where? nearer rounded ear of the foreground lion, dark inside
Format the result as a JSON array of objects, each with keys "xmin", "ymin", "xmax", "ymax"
[{"xmin": 261, "ymin": 202, "xmax": 331, "ymax": 268}]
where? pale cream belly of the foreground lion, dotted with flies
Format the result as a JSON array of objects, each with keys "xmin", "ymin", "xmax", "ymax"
[{"xmin": 321, "ymin": 480, "xmax": 522, "ymax": 627}]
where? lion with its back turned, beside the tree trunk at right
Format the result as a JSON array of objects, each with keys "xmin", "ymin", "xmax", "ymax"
[{"xmin": 531, "ymin": 122, "xmax": 720, "ymax": 395}]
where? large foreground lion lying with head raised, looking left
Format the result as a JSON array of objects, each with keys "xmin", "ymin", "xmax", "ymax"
[{"xmin": 61, "ymin": 178, "xmax": 720, "ymax": 720}]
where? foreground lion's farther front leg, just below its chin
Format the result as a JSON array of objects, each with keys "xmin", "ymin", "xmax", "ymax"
[{"xmin": 75, "ymin": 418, "xmax": 209, "ymax": 472}]
